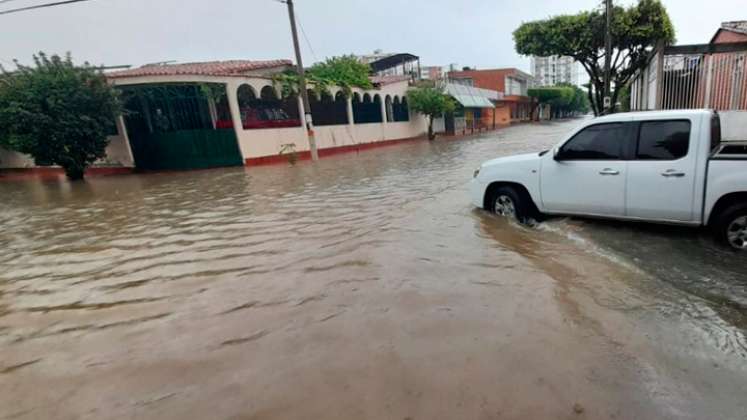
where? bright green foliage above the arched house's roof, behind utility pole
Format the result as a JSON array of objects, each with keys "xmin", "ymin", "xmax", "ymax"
[{"xmin": 275, "ymin": 55, "xmax": 373, "ymax": 95}]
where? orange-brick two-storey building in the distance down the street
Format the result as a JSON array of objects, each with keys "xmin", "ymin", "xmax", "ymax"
[{"xmin": 448, "ymin": 67, "xmax": 534, "ymax": 122}]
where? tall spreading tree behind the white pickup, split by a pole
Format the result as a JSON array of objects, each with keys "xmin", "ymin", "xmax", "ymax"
[{"xmin": 514, "ymin": 0, "xmax": 674, "ymax": 115}]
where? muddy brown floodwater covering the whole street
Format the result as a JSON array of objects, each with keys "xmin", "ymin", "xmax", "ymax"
[{"xmin": 0, "ymin": 122, "xmax": 747, "ymax": 419}]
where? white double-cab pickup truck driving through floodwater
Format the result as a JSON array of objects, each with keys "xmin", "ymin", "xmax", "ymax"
[{"xmin": 470, "ymin": 110, "xmax": 747, "ymax": 251}]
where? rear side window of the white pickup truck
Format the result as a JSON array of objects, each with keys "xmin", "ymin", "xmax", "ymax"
[{"xmin": 636, "ymin": 120, "xmax": 690, "ymax": 160}]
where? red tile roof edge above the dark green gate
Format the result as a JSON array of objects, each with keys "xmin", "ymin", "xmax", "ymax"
[{"xmin": 107, "ymin": 60, "xmax": 293, "ymax": 79}]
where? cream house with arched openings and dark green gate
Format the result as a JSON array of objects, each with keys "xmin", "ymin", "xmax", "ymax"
[{"xmin": 0, "ymin": 60, "xmax": 426, "ymax": 169}]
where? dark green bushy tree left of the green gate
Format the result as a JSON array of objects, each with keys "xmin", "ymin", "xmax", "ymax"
[{"xmin": 0, "ymin": 53, "xmax": 121, "ymax": 180}]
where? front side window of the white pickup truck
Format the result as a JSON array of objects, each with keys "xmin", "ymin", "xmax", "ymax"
[{"xmin": 558, "ymin": 123, "xmax": 628, "ymax": 160}]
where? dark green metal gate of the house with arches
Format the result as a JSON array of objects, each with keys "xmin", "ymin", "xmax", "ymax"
[{"xmin": 121, "ymin": 84, "xmax": 243, "ymax": 169}]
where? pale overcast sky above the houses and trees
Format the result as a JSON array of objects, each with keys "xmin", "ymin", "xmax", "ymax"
[{"xmin": 0, "ymin": 0, "xmax": 747, "ymax": 71}]
